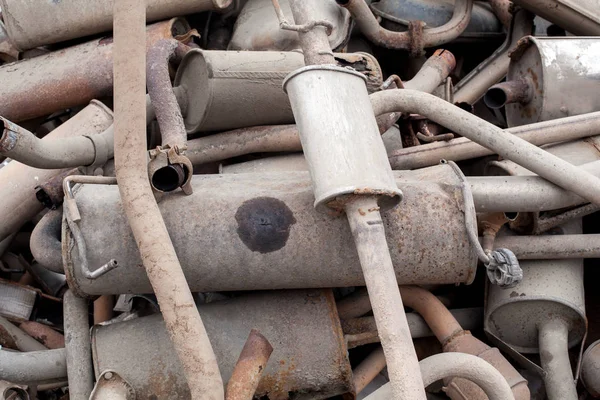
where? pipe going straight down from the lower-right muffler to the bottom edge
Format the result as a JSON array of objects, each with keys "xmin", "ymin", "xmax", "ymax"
[{"xmin": 539, "ymin": 318, "xmax": 578, "ymax": 400}]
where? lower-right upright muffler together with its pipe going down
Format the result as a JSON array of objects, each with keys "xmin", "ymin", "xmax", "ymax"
[{"xmin": 484, "ymin": 221, "xmax": 587, "ymax": 400}]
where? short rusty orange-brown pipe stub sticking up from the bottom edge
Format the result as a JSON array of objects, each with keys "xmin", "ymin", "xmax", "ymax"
[{"xmin": 225, "ymin": 329, "xmax": 273, "ymax": 400}]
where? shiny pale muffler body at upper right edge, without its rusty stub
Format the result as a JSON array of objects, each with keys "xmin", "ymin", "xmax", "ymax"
[{"xmin": 506, "ymin": 36, "xmax": 600, "ymax": 127}]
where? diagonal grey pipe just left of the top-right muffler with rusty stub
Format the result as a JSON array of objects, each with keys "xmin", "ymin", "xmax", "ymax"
[{"xmin": 454, "ymin": 9, "xmax": 534, "ymax": 104}]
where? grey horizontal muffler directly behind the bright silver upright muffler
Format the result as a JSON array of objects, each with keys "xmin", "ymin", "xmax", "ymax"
[{"xmin": 175, "ymin": 50, "xmax": 383, "ymax": 133}]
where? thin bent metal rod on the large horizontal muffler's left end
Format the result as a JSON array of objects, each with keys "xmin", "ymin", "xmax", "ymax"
[{"xmin": 63, "ymin": 175, "xmax": 118, "ymax": 279}]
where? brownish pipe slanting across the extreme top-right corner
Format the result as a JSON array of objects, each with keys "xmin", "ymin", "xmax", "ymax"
[{"xmin": 513, "ymin": 0, "xmax": 600, "ymax": 36}]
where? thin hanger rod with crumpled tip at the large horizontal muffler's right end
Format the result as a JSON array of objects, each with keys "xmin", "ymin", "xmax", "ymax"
[{"xmin": 440, "ymin": 160, "xmax": 523, "ymax": 289}]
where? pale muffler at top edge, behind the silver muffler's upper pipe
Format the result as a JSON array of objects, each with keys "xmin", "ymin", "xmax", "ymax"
[{"xmin": 228, "ymin": 0, "xmax": 351, "ymax": 51}]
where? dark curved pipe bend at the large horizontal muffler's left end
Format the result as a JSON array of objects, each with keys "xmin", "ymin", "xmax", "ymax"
[{"xmin": 29, "ymin": 209, "xmax": 65, "ymax": 274}]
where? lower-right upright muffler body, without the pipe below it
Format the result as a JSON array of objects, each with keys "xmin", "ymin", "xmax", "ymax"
[{"xmin": 484, "ymin": 220, "xmax": 587, "ymax": 353}]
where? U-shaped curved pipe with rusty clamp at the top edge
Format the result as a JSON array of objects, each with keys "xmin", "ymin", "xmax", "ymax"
[{"xmin": 336, "ymin": 0, "xmax": 473, "ymax": 54}]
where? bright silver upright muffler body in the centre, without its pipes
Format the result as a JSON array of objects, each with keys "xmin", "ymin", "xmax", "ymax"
[{"xmin": 284, "ymin": 65, "xmax": 402, "ymax": 211}]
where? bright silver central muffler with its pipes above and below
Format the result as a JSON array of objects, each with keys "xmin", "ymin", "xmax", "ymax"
[{"xmin": 283, "ymin": 0, "xmax": 425, "ymax": 400}]
